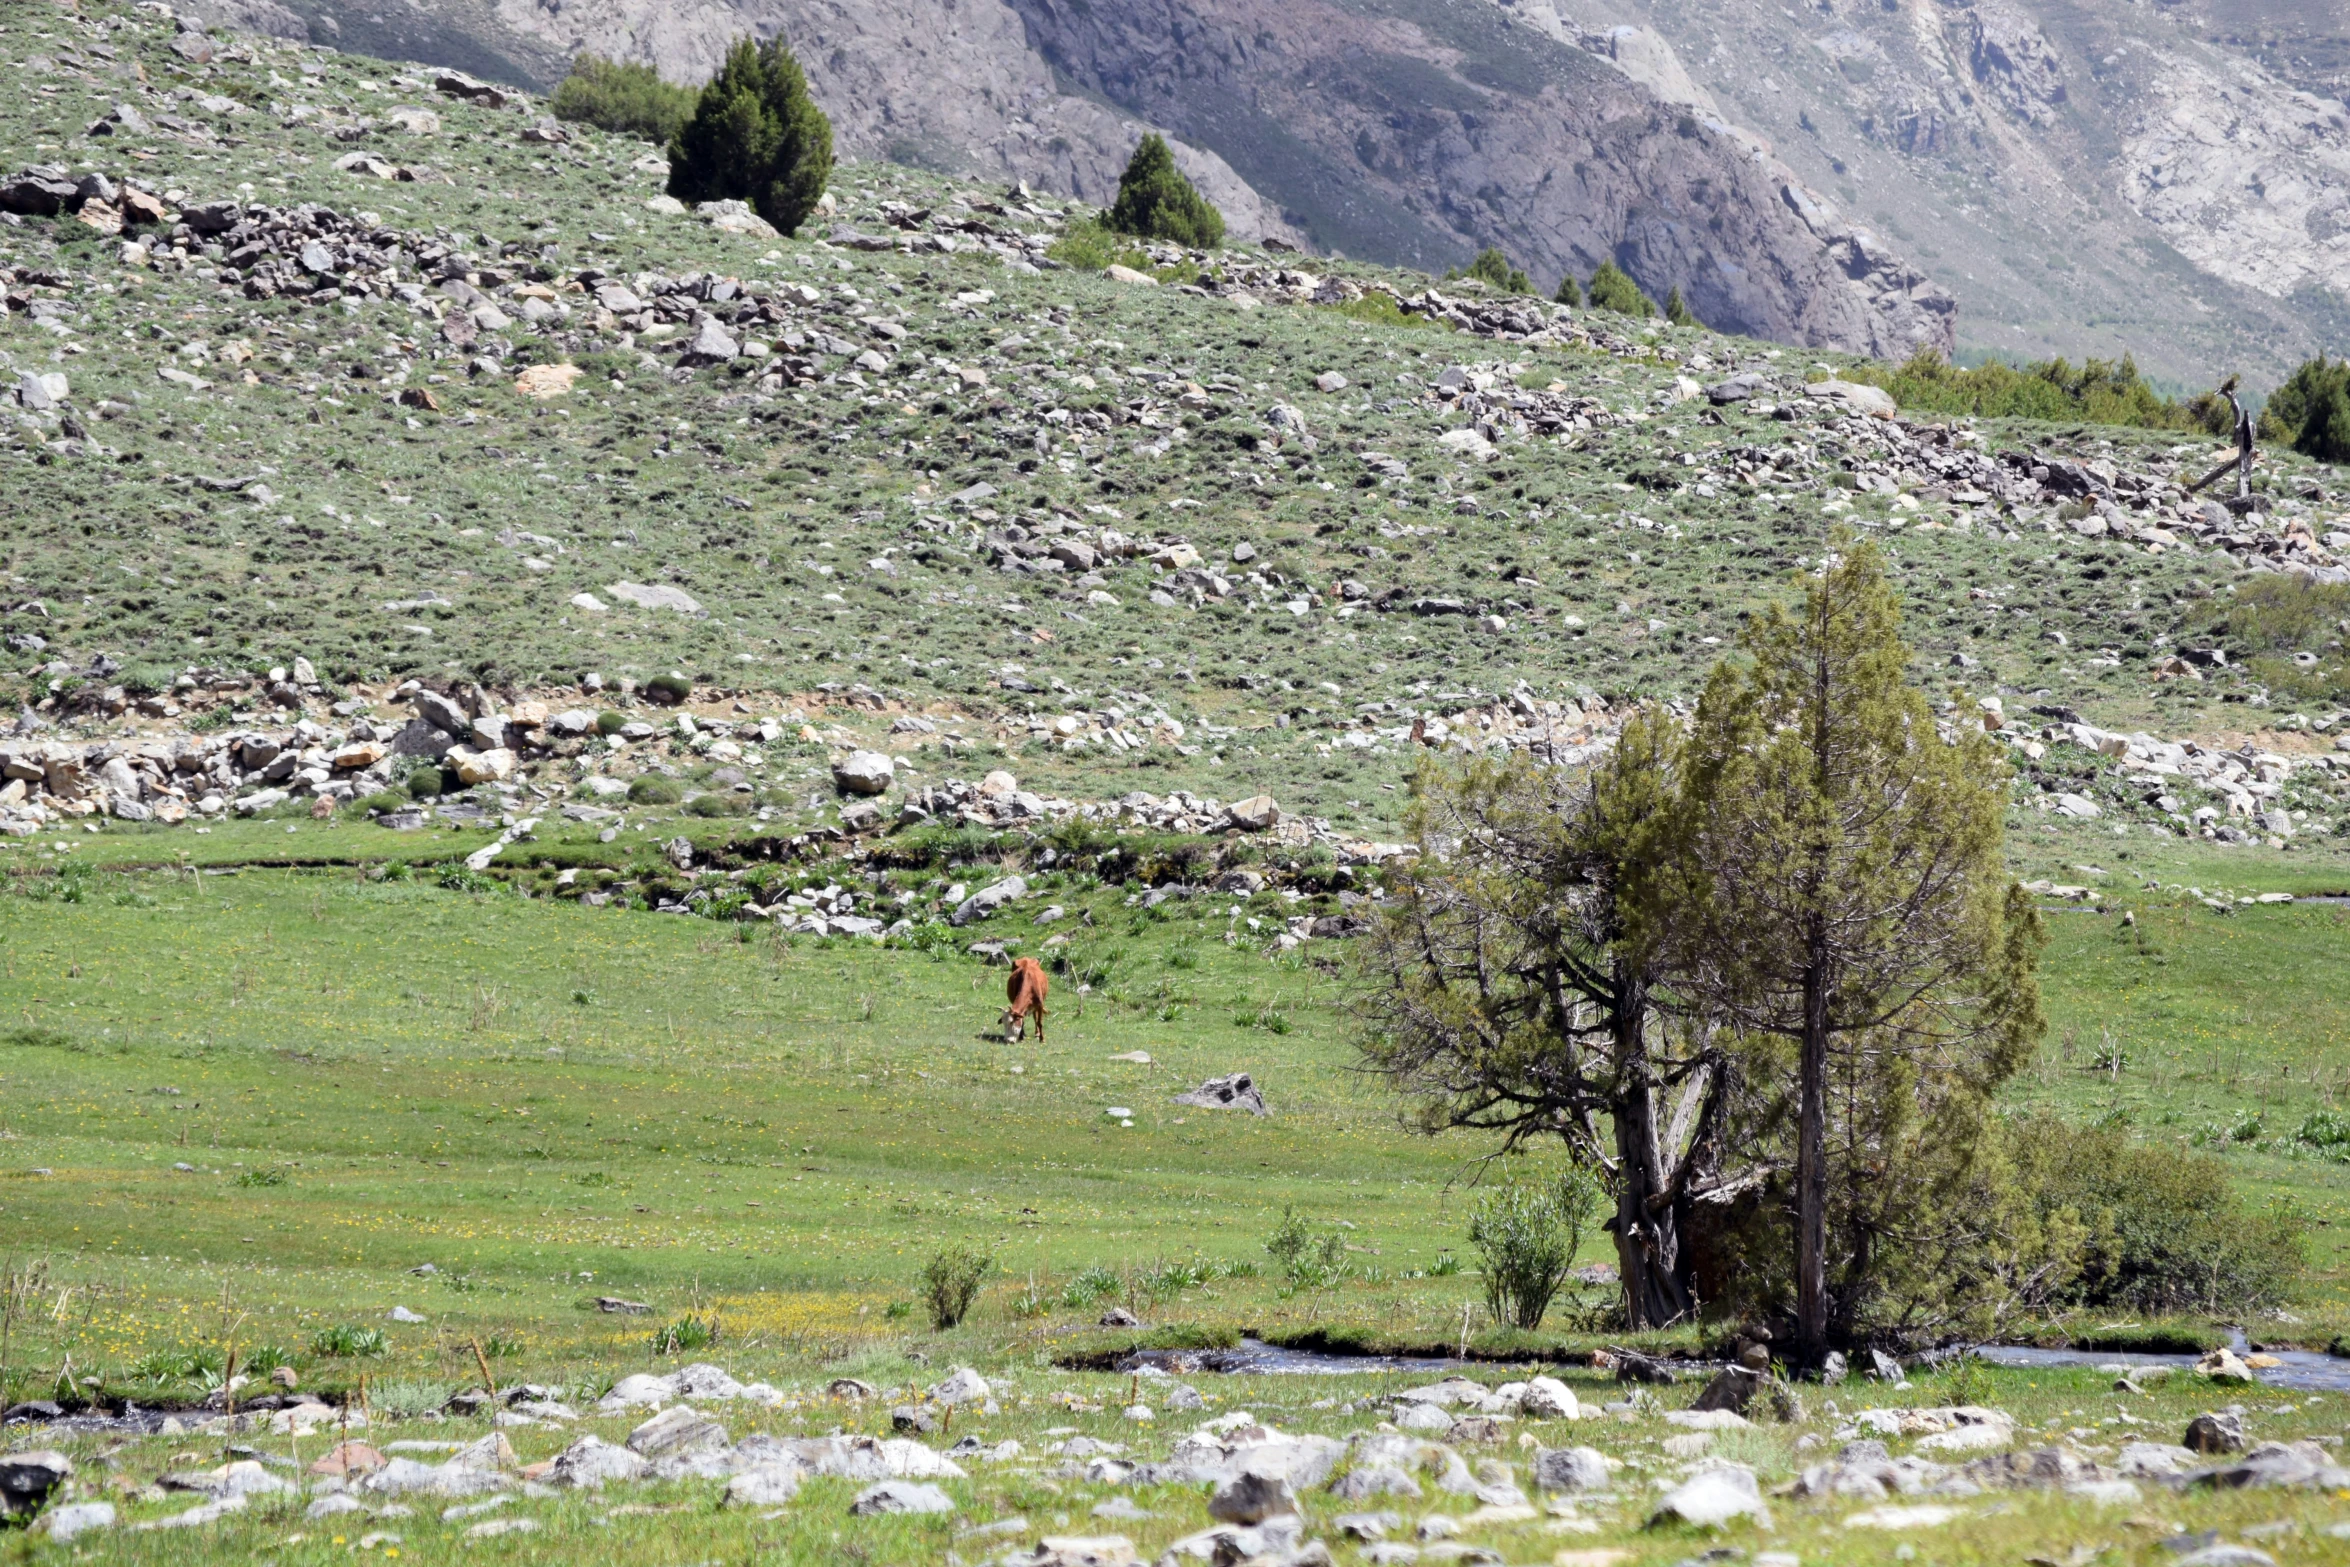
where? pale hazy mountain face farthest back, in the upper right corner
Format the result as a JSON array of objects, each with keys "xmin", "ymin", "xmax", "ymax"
[{"xmin": 1485, "ymin": 0, "xmax": 2350, "ymax": 388}]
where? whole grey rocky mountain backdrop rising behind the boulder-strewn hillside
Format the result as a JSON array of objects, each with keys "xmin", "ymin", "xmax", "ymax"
[{"xmin": 233, "ymin": 0, "xmax": 2350, "ymax": 388}]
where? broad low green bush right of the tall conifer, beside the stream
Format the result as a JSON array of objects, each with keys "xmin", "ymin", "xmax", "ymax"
[{"xmin": 2009, "ymin": 1116, "xmax": 2308, "ymax": 1316}]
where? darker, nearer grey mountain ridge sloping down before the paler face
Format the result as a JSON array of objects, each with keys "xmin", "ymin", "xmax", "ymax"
[{"xmin": 202, "ymin": 0, "xmax": 1955, "ymax": 355}]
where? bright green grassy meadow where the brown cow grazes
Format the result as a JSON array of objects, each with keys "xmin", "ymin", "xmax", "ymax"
[{"xmin": 0, "ymin": 841, "xmax": 2350, "ymax": 1562}]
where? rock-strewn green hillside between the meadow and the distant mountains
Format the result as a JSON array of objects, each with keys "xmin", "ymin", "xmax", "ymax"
[{"xmin": 0, "ymin": 7, "xmax": 2350, "ymax": 853}]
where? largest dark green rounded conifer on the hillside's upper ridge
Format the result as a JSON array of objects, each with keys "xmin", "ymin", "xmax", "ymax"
[{"xmin": 670, "ymin": 33, "xmax": 832, "ymax": 235}]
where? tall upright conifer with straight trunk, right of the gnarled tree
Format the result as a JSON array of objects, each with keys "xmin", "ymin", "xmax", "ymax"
[{"xmin": 1678, "ymin": 540, "xmax": 2040, "ymax": 1365}]
